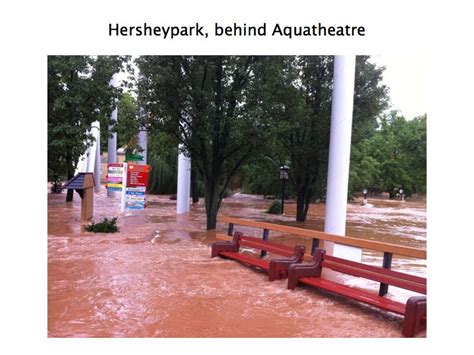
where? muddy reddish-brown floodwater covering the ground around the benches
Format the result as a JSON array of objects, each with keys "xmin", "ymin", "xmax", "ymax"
[{"xmin": 48, "ymin": 189, "xmax": 426, "ymax": 338}]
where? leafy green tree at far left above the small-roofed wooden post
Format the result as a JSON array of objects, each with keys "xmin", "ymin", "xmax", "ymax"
[{"xmin": 48, "ymin": 56, "xmax": 127, "ymax": 199}]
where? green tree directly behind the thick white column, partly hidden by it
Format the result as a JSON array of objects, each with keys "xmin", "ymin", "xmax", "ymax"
[{"xmin": 260, "ymin": 56, "xmax": 388, "ymax": 221}]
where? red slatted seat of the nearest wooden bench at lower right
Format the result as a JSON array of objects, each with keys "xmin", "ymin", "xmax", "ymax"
[{"xmin": 298, "ymin": 277, "xmax": 405, "ymax": 315}]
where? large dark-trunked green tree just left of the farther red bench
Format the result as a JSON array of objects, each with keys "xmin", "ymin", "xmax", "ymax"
[{"xmin": 137, "ymin": 56, "xmax": 272, "ymax": 229}]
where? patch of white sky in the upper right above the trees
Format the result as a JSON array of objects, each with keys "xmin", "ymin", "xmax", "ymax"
[{"xmin": 372, "ymin": 55, "xmax": 428, "ymax": 120}]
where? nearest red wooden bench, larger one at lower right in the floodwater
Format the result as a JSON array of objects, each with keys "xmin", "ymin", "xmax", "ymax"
[{"xmin": 288, "ymin": 249, "xmax": 426, "ymax": 337}]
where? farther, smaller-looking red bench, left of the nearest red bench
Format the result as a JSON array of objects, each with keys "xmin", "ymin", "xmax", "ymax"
[{"xmin": 211, "ymin": 232, "xmax": 305, "ymax": 281}]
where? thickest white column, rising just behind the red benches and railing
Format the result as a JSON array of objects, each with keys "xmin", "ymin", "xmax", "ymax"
[{"xmin": 324, "ymin": 55, "xmax": 362, "ymax": 261}]
